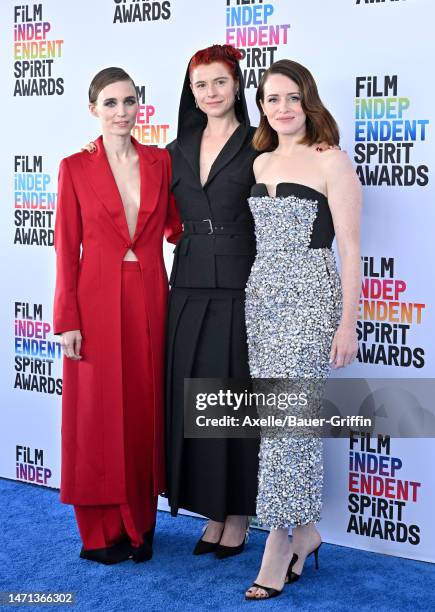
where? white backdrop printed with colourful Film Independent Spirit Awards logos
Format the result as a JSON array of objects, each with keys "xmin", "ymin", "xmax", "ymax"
[{"xmin": 0, "ymin": 0, "xmax": 435, "ymax": 561}]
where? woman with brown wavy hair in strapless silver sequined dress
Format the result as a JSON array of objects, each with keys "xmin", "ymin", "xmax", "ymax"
[{"xmin": 246, "ymin": 60, "xmax": 361, "ymax": 599}]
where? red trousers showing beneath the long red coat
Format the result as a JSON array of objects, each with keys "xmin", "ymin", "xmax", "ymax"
[{"xmin": 74, "ymin": 261, "xmax": 157, "ymax": 550}]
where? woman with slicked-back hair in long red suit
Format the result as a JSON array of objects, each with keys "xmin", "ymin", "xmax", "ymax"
[{"xmin": 54, "ymin": 68, "xmax": 181, "ymax": 563}]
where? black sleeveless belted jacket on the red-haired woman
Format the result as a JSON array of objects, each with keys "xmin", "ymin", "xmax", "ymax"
[{"xmin": 168, "ymin": 123, "xmax": 258, "ymax": 289}]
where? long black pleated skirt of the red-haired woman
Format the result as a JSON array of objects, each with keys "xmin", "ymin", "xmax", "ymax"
[{"xmin": 166, "ymin": 288, "xmax": 259, "ymax": 521}]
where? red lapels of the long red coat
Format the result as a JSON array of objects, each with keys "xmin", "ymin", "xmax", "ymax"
[{"xmin": 83, "ymin": 136, "xmax": 162, "ymax": 244}]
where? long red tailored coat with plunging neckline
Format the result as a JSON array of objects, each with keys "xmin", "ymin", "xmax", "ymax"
[{"xmin": 54, "ymin": 137, "xmax": 182, "ymax": 505}]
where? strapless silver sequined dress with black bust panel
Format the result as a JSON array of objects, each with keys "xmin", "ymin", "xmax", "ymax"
[{"xmin": 245, "ymin": 183, "xmax": 342, "ymax": 528}]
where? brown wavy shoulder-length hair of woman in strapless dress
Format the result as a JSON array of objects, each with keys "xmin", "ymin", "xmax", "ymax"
[{"xmin": 252, "ymin": 60, "xmax": 340, "ymax": 152}]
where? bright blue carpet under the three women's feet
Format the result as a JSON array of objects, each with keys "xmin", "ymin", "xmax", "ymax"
[{"xmin": 0, "ymin": 479, "xmax": 435, "ymax": 612}]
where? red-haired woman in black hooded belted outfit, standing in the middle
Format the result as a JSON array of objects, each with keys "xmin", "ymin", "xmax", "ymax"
[{"xmin": 166, "ymin": 45, "xmax": 258, "ymax": 558}]
